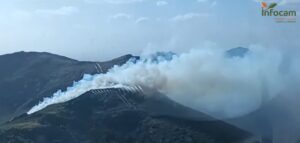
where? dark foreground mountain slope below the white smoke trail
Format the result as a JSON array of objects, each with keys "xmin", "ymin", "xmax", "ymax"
[{"xmin": 0, "ymin": 89, "xmax": 250, "ymax": 143}]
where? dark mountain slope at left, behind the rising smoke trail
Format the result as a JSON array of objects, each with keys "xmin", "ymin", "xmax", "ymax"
[{"xmin": 0, "ymin": 52, "xmax": 133, "ymax": 124}]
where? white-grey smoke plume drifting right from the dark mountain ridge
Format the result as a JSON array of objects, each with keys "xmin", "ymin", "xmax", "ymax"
[{"xmin": 28, "ymin": 46, "xmax": 299, "ymax": 118}]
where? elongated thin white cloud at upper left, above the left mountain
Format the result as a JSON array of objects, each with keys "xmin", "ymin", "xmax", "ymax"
[{"xmin": 35, "ymin": 6, "xmax": 79, "ymax": 15}]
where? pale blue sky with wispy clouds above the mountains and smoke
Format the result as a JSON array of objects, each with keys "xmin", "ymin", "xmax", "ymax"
[{"xmin": 0, "ymin": 0, "xmax": 300, "ymax": 61}]
